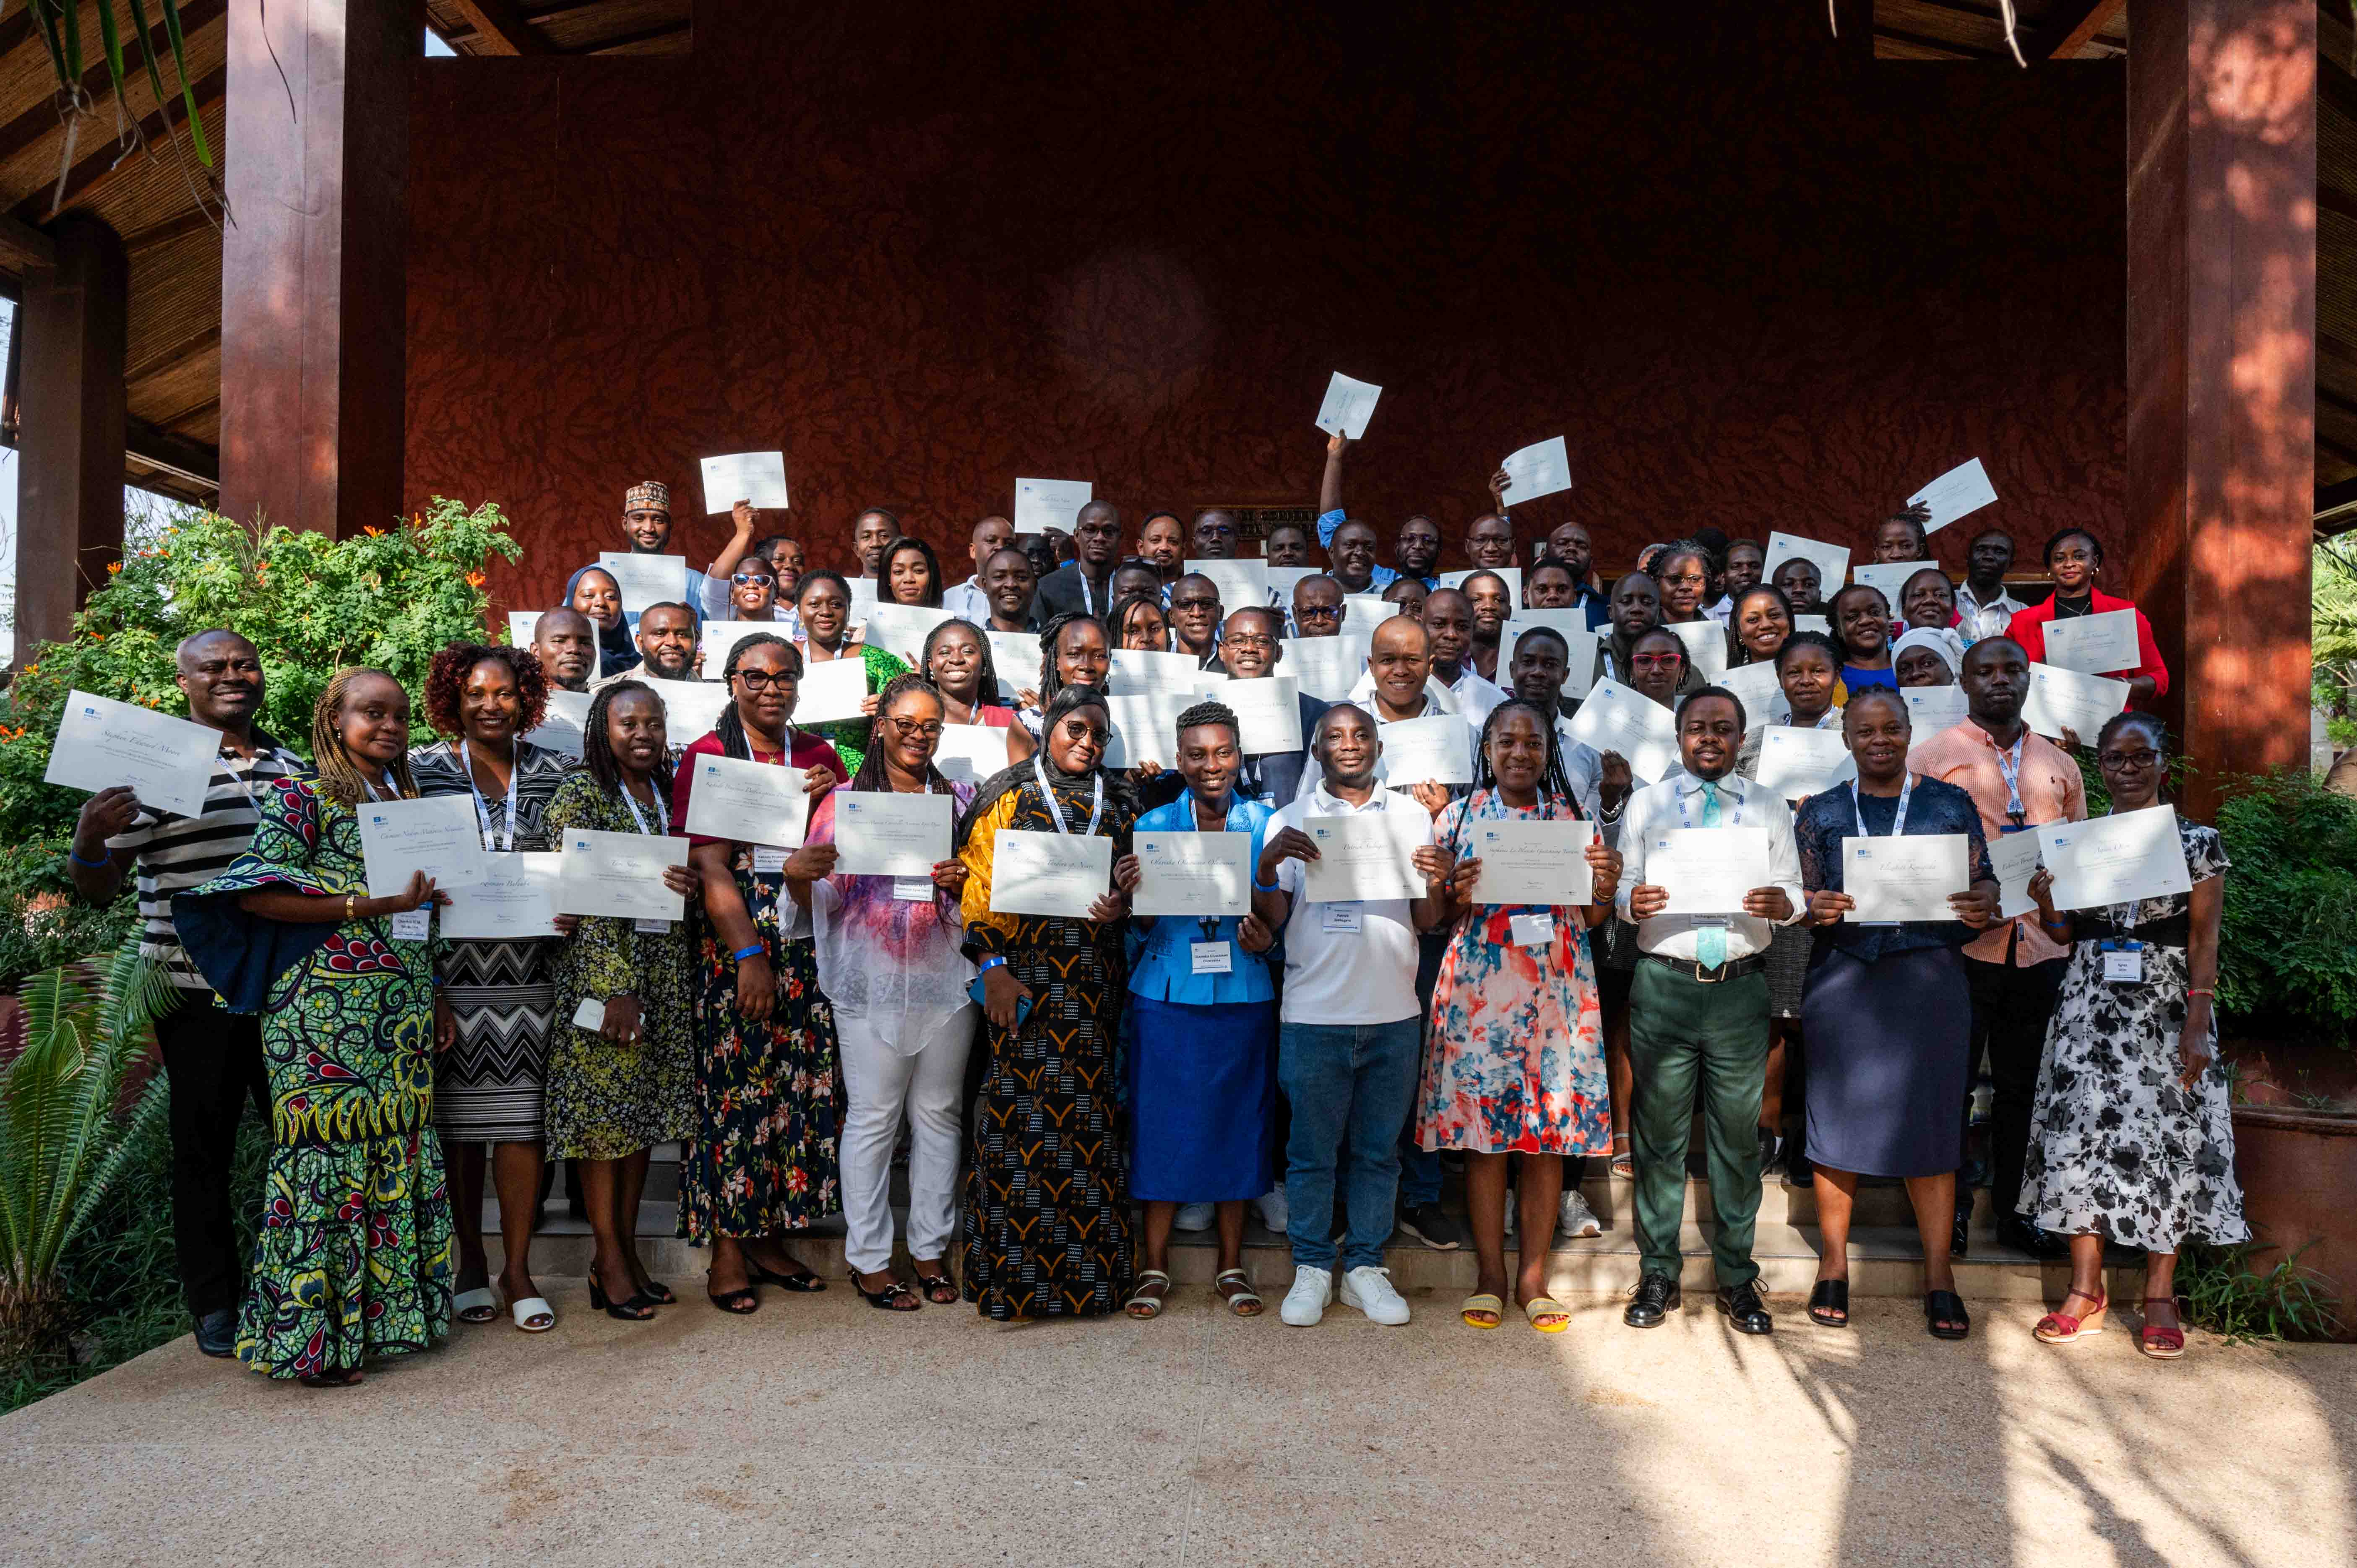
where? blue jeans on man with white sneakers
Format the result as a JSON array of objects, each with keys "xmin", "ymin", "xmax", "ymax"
[{"xmin": 1277, "ymin": 1019, "xmax": 1424, "ymax": 1271}]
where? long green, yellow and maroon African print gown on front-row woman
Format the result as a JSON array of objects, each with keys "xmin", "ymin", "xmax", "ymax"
[{"xmin": 182, "ymin": 778, "xmax": 450, "ymax": 1377}]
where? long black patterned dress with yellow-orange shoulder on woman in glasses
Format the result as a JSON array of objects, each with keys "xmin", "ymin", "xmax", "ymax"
[{"xmin": 959, "ymin": 780, "xmax": 1136, "ymax": 1321}]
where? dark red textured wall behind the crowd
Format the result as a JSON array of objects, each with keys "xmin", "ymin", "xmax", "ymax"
[{"xmin": 408, "ymin": 0, "xmax": 2126, "ymax": 606}]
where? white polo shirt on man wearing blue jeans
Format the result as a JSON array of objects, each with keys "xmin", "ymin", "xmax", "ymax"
[{"xmin": 1254, "ymin": 785, "xmax": 1433, "ymax": 1023}]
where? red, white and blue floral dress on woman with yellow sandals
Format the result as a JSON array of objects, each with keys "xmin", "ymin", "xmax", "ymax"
[{"xmin": 1417, "ymin": 788, "xmax": 1612, "ymax": 1155}]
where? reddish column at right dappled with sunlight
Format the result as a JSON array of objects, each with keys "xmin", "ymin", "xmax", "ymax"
[{"xmin": 2130, "ymin": 0, "xmax": 2317, "ymax": 816}]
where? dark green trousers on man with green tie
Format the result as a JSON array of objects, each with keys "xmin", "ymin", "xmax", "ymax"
[{"xmin": 1629, "ymin": 960, "xmax": 1768, "ymax": 1285}]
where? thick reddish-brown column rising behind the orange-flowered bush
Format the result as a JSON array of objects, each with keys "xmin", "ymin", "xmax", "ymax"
[{"xmin": 221, "ymin": 0, "xmax": 424, "ymax": 538}]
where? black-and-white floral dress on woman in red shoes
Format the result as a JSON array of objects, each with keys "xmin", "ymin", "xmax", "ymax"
[{"xmin": 2020, "ymin": 821, "xmax": 2251, "ymax": 1252}]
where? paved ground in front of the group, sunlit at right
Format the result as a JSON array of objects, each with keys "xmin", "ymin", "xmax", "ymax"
[{"xmin": 0, "ymin": 1278, "xmax": 2357, "ymax": 1568}]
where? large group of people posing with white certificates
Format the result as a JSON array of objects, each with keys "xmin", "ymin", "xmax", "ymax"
[{"xmin": 71, "ymin": 450, "xmax": 2246, "ymax": 1386}]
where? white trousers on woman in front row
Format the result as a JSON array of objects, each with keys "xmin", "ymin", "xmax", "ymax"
[{"xmin": 834, "ymin": 1004, "xmax": 983, "ymax": 1273}]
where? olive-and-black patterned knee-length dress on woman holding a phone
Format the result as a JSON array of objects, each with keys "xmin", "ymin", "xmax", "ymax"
[{"xmin": 547, "ymin": 773, "xmax": 695, "ymax": 1160}]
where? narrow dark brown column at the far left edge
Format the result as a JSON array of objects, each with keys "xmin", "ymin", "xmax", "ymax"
[{"xmin": 16, "ymin": 215, "xmax": 130, "ymax": 663}]
